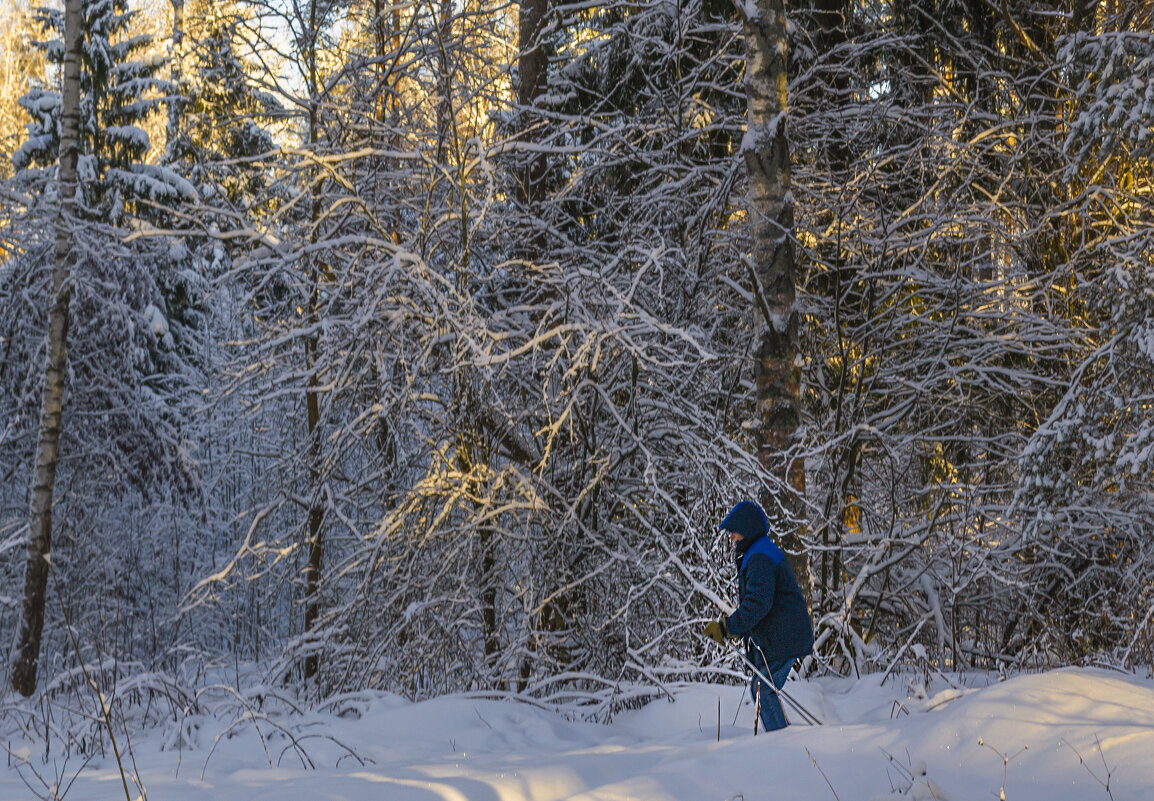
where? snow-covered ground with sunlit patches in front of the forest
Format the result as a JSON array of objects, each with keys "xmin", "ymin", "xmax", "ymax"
[{"xmin": 0, "ymin": 669, "xmax": 1154, "ymax": 801}]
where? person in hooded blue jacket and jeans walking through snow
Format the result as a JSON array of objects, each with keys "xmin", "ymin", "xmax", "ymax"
[{"xmin": 705, "ymin": 501, "xmax": 814, "ymax": 732}]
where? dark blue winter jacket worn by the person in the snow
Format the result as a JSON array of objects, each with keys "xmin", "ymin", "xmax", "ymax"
[{"xmin": 725, "ymin": 536, "xmax": 814, "ymax": 664}]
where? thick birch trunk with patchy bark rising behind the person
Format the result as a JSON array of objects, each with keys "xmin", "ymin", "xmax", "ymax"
[{"xmin": 742, "ymin": 0, "xmax": 809, "ymax": 596}]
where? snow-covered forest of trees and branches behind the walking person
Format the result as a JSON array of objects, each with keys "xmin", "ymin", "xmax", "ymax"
[{"xmin": 0, "ymin": 0, "xmax": 1154, "ymax": 716}]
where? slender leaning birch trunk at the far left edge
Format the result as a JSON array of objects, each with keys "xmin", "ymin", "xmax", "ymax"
[{"xmin": 12, "ymin": 0, "xmax": 84, "ymax": 696}]
